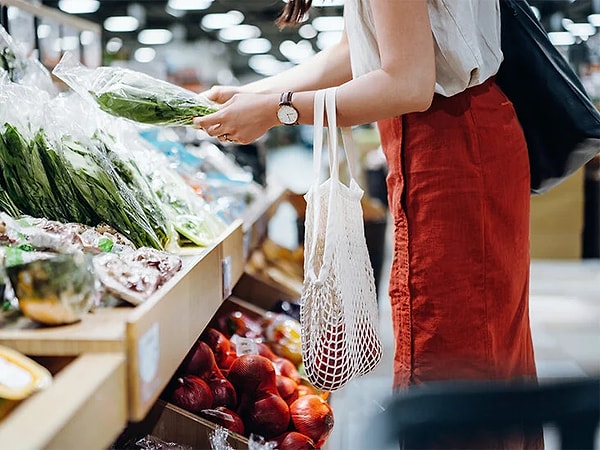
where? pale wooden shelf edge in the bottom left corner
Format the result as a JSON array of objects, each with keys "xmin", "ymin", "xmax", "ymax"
[{"xmin": 0, "ymin": 353, "xmax": 127, "ymax": 450}]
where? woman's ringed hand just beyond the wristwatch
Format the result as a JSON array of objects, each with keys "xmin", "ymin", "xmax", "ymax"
[{"xmin": 194, "ymin": 92, "xmax": 280, "ymax": 144}]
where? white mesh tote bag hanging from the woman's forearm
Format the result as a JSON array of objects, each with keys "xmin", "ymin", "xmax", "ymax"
[{"xmin": 300, "ymin": 88, "xmax": 382, "ymax": 391}]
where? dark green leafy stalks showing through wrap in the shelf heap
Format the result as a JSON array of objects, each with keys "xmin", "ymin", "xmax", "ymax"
[{"xmin": 0, "ymin": 124, "xmax": 171, "ymax": 249}]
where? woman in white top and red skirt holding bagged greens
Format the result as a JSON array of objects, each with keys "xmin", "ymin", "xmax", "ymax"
[{"xmin": 195, "ymin": 0, "xmax": 537, "ymax": 446}]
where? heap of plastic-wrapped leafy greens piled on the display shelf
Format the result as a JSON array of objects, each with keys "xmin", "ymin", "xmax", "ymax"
[{"xmin": 0, "ymin": 34, "xmax": 226, "ymax": 252}]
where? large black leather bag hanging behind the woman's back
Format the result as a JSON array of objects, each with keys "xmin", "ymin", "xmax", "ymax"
[{"xmin": 496, "ymin": 0, "xmax": 600, "ymax": 194}]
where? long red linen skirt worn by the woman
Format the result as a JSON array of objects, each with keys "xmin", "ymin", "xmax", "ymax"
[{"xmin": 378, "ymin": 80, "xmax": 535, "ymax": 388}]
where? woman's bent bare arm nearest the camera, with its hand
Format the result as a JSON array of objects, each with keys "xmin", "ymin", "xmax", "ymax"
[{"xmin": 195, "ymin": 0, "xmax": 435, "ymax": 143}]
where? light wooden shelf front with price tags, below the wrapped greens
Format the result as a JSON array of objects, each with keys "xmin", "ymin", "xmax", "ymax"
[{"xmin": 0, "ymin": 182, "xmax": 285, "ymax": 422}]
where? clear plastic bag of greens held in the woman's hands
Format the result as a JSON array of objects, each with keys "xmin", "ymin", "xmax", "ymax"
[{"xmin": 52, "ymin": 52, "xmax": 217, "ymax": 126}]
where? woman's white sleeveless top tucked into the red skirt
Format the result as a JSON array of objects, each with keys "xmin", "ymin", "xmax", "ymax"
[{"xmin": 344, "ymin": 0, "xmax": 502, "ymax": 97}]
